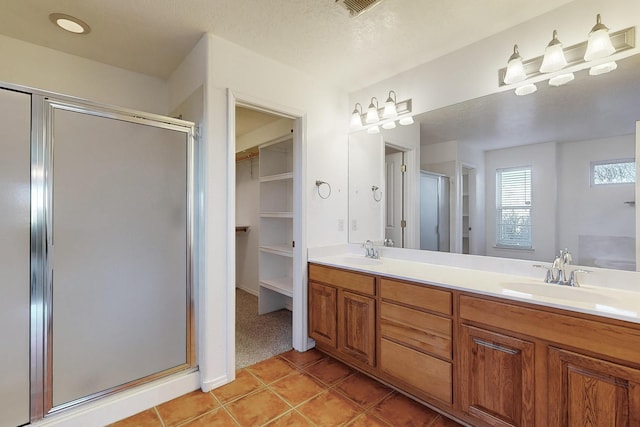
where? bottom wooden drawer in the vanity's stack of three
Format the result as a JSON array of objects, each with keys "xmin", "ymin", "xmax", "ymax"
[{"xmin": 380, "ymin": 338, "xmax": 453, "ymax": 403}]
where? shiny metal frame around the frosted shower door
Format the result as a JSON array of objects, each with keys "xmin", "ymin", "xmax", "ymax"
[{"xmin": 29, "ymin": 94, "xmax": 197, "ymax": 422}]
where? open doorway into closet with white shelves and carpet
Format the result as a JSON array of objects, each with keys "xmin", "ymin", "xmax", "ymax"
[{"xmin": 235, "ymin": 104, "xmax": 300, "ymax": 369}]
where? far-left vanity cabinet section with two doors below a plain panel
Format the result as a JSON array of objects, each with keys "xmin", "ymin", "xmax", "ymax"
[{"xmin": 309, "ymin": 264, "xmax": 376, "ymax": 367}]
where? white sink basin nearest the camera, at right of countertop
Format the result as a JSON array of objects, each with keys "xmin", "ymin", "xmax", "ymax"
[{"xmin": 502, "ymin": 282, "xmax": 615, "ymax": 304}]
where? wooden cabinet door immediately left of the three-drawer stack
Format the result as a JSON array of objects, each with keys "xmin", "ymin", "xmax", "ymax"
[{"xmin": 338, "ymin": 290, "xmax": 376, "ymax": 366}]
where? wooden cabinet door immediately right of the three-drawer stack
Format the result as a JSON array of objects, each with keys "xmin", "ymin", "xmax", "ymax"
[{"xmin": 460, "ymin": 326, "xmax": 534, "ymax": 426}]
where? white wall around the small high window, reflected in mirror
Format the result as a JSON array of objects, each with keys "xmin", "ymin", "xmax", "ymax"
[{"xmin": 558, "ymin": 135, "xmax": 637, "ymax": 267}]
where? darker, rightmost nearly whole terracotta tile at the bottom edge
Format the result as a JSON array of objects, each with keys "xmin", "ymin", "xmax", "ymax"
[{"xmin": 372, "ymin": 393, "xmax": 440, "ymax": 427}]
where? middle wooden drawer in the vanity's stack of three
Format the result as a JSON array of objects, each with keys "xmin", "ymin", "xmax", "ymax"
[{"xmin": 380, "ymin": 302, "xmax": 451, "ymax": 360}]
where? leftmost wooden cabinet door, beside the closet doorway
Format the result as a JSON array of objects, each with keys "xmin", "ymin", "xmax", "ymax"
[{"xmin": 309, "ymin": 282, "xmax": 338, "ymax": 348}]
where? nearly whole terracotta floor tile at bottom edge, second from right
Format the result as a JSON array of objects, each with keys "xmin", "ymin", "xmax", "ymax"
[{"xmin": 296, "ymin": 390, "xmax": 362, "ymax": 426}]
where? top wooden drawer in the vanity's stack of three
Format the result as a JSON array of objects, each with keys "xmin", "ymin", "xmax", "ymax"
[{"xmin": 380, "ymin": 279, "xmax": 451, "ymax": 315}]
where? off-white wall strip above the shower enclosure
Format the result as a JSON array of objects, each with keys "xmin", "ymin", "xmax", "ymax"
[{"xmin": 0, "ymin": 35, "xmax": 169, "ymax": 115}]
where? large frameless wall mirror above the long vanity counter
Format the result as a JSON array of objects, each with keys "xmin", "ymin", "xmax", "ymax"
[{"xmin": 349, "ymin": 55, "xmax": 640, "ymax": 270}]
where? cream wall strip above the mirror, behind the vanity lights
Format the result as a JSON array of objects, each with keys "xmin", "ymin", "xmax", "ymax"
[{"xmin": 349, "ymin": 0, "xmax": 640, "ymax": 118}]
